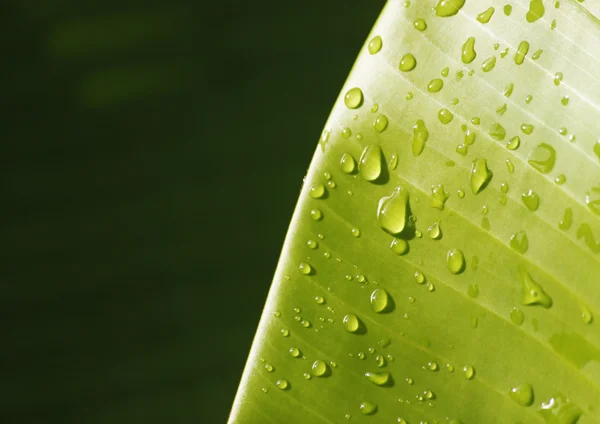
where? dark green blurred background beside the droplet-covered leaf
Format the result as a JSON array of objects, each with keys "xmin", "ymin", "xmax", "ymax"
[{"xmin": 0, "ymin": 0, "xmax": 384, "ymax": 424}]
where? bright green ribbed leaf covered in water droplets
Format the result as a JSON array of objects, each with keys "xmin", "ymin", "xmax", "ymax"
[{"xmin": 230, "ymin": 0, "xmax": 600, "ymax": 424}]
